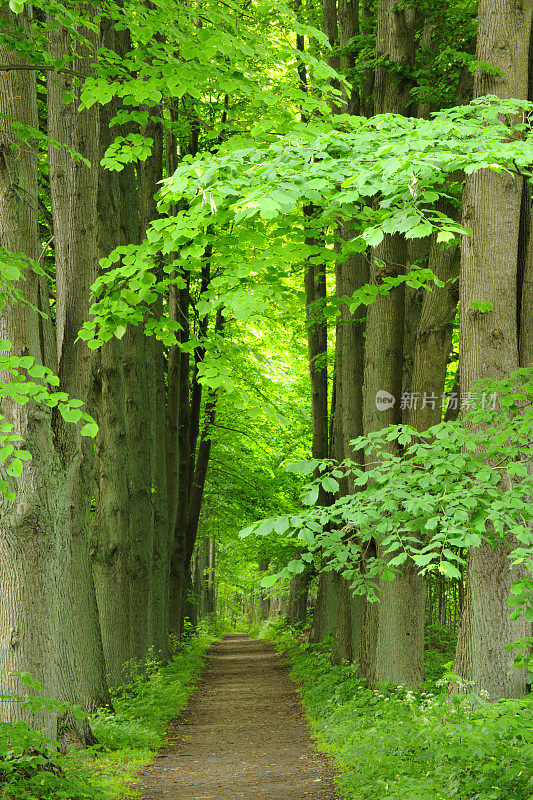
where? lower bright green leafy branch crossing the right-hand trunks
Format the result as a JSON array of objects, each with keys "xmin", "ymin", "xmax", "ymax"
[{"xmin": 240, "ymin": 369, "xmax": 533, "ymax": 613}]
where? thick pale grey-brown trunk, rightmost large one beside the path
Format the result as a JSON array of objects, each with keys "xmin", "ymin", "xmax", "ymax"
[{"xmin": 454, "ymin": 0, "xmax": 533, "ymax": 700}]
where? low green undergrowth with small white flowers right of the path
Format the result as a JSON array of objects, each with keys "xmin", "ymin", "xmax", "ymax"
[{"xmin": 263, "ymin": 624, "xmax": 533, "ymax": 800}]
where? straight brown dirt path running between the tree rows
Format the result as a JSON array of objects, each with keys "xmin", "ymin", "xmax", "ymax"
[{"xmin": 138, "ymin": 636, "xmax": 336, "ymax": 800}]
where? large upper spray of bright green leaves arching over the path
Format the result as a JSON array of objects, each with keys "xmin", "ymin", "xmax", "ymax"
[{"xmin": 80, "ymin": 97, "xmax": 533, "ymax": 360}]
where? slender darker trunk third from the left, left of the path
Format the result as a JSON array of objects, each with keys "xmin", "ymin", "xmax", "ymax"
[{"xmin": 90, "ymin": 22, "xmax": 138, "ymax": 686}]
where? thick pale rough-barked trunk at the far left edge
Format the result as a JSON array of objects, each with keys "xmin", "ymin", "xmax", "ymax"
[{"xmin": 0, "ymin": 8, "xmax": 102, "ymax": 743}]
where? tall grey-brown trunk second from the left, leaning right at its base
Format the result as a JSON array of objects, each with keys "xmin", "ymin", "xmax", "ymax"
[{"xmin": 47, "ymin": 14, "xmax": 109, "ymax": 711}]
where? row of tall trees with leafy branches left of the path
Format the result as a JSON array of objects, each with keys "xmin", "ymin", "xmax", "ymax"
[{"xmin": 0, "ymin": 2, "xmax": 316, "ymax": 740}]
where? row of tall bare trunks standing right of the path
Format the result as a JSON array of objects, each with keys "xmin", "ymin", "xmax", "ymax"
[{"xmin": 298, "ymin": 0, "xmax": 533, "ymax": 698}]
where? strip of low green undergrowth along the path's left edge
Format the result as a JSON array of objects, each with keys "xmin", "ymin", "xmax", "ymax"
[{"xmin": 0, "ymin": 630, "xmax": 215, "ymax": 800}]
